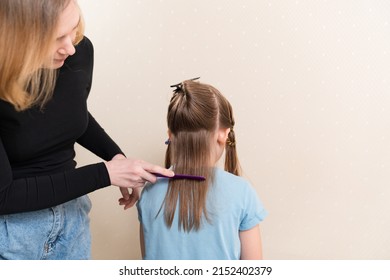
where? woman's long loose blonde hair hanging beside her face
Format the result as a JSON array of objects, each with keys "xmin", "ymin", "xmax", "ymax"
[{"xmin": 0, "ymin": 0, "xmax": 84, "ymax": 111}]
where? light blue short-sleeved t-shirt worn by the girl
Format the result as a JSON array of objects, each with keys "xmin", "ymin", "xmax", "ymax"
[{"xmin": 137, "ymin": 168, "xmax": 267, "ymax": 260}]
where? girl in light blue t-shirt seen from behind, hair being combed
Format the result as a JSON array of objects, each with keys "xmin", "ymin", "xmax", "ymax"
[{"xmin": 137, "ymin": 77, "xmax": 267, "ymax": 260}]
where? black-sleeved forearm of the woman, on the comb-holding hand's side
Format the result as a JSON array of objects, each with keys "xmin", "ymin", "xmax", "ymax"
[{"xmin": 0, "ymin": 158, "xmax": 110, "ymax": 215}]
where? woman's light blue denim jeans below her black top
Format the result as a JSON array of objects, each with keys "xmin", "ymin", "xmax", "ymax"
[{"xmin": 0, "ymin": 195, "xmax": 91, "ymax": 260}]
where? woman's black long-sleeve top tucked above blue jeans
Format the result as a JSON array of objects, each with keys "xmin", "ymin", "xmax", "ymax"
[{"xmin": 0, "ymin": 37, "xmax": 122, "ymax": 214}]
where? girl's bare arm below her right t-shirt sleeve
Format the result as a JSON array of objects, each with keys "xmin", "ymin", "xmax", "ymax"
[{"xmin": 240, "ymin": 225, "xmax": 263, "ymax": 260}]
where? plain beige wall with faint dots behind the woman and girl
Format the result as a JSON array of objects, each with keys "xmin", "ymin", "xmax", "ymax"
[{"xmin": 77, "ymin": 0, "xmax": 390, "ymax": 259}]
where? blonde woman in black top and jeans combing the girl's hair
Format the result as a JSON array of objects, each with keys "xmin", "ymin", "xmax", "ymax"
[{"xmin": 0, "ymin": 0, "xmax": 173, "ymax": 259}]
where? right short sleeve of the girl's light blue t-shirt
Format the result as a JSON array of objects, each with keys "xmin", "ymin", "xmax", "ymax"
[{"xmin": 240, "ymin": 184, "xmax": 268, "ymax": 231}]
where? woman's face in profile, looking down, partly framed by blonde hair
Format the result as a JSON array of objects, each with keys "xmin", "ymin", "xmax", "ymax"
[{"xmin": 46, "ymin": 0, "xmax": 80, "ymax": 69}]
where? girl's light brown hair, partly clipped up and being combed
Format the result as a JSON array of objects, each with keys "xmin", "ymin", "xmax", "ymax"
[{"xmin": 164, "ymin": 80, "xmax": 241, "ymax": 232}]
